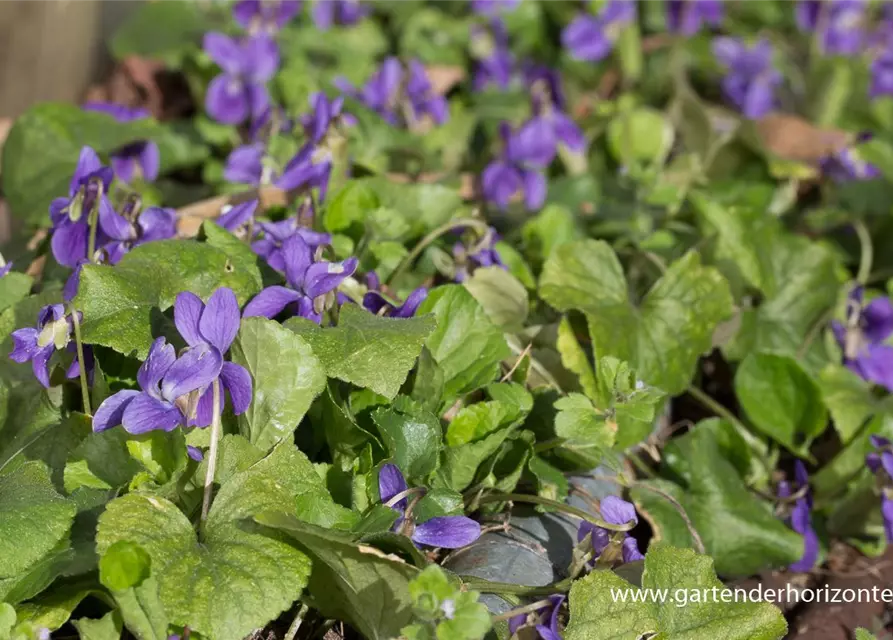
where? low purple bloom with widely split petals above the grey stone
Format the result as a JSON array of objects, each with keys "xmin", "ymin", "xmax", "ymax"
[{"xmin": 378, "ymin": 463, "xmax": 481, "ymax": 549}]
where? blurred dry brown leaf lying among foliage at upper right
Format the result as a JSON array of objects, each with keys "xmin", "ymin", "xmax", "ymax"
[{"xmin": 756, "ymin": 113, "xmax": 851, "ymax": 164}]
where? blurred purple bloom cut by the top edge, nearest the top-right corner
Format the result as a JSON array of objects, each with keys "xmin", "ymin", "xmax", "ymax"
[{"xmin": 796, "ymin": 0, "xmax": 867, "ymax": 56}]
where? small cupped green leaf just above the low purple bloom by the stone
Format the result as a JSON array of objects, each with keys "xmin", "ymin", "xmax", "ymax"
[{"xmin": 372, "ymin": 398, "xmax": 443, "ymax": 478}]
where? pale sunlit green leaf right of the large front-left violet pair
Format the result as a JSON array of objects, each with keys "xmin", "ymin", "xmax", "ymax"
[{"xmin": 232, "ymin": 318, "xmax": 326, "ymax": 450}]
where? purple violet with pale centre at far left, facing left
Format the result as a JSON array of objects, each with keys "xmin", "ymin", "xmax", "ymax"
[{"xmin": 9, "ymin": 304, "xmax": 93, "ymax": 388}]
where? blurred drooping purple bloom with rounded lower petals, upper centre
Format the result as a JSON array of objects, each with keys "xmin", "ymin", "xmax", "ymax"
[{"xmin": 481, "ymin": 123, "xmax": 547, "ymax": 210}]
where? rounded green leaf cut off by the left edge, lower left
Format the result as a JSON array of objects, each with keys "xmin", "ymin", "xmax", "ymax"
[{"xmin": 0, "ymin": 462, "xmax": 76, "ymax": 578}]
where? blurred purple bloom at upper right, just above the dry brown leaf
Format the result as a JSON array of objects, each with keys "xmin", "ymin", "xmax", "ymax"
[{"xmin": 713, "ymin": 37, "xmax": 782, "ymax": 120}]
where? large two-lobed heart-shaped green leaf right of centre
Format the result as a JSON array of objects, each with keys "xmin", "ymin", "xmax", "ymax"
[{"xmin": 540, "ymin": 240, "xmax": 732, "ymax": 395}]
